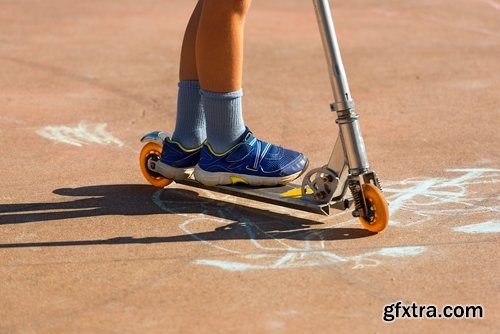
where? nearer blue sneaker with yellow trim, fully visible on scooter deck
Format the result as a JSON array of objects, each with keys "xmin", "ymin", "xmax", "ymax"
[{"xmin": 194, "ymin": 128, "xmax": 308, "ymax": 186}]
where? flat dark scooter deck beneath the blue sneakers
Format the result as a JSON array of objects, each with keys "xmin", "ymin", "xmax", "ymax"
[{"xmin": 178, "ymin": 179, "xmax": 350, "ymax": 216}]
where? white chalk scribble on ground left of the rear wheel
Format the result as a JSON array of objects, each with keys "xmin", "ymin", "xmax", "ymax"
[{"xmin": 36, "ymin": 121, "xmax": 123, "ymax": 147}]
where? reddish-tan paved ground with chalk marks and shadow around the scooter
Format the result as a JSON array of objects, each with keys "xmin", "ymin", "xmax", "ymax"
[{"xmin": 0, "ymin": 0, "xmax": 500, "ymax": 333}]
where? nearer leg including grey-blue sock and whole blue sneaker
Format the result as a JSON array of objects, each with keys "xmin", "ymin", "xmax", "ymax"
[{"xmin": 194, "ymin": 0, "xmax": 307, "ymax": 186}]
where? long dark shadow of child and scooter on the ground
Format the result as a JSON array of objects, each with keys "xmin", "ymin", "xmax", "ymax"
[{"xmin": 0, "ymin": 184, "xmax": 375, "ymax": 248}]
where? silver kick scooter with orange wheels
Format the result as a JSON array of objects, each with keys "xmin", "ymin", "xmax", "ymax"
[{"xmin": 140, "ymin": 0, "xmax": 389, "ymax": 232}]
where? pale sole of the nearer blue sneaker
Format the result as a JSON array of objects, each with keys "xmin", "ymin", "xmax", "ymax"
[{"xmin": 194, "ymin": 164, "xmax": 307, "ymax": 187}]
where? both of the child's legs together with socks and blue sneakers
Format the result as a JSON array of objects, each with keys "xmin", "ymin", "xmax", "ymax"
[{"xmin": 166, "ymin": 0, "xmax": 307, "ymax": 186}]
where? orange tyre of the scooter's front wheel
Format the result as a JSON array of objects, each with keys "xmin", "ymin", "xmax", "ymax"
[{"xmin": 359, "ymin": 183, "xmax": 389, "ymax": 232}]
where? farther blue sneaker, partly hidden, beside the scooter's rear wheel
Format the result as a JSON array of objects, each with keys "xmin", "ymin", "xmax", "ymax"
[{"xmin": 156, "ymin": 137, "xmax": 201, "ymax": 181}]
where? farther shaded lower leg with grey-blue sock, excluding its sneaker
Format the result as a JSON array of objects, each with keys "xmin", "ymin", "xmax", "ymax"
[{"xmin": 172, "ymin": 0, "xmax": 206, "ymax": 148}]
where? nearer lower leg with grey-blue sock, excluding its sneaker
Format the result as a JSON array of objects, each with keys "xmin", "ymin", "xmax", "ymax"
[{"xmin": 196, "ymin": 0, "xmax": 250, "ymax": 153}]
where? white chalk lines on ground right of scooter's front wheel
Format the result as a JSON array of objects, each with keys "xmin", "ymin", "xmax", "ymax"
[{"xmin": 384, "ymin": 168, "xmax": 500, "ymax": 226}]
